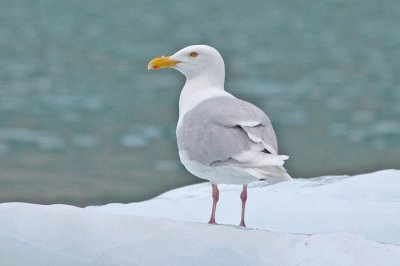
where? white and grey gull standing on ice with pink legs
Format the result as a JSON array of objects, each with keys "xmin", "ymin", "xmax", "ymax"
[{"xmin": 148, "ymin": 45, "xmax": 291, "ymax": 227}]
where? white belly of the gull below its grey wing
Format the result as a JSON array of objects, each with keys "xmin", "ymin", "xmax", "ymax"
[{"xmin": 179, "ymin": 151, "xmax": 258, "ymax": 184}]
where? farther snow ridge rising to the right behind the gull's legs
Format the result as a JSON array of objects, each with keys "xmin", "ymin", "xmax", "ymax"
[{"xmin": 90, "ymin": 170, "xmax": 400, "ymax": 245}]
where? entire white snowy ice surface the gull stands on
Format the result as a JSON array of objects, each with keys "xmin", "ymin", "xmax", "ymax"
[{"xmin": 0, "ymin": 170, "xmax": 400, "ymax": 265}]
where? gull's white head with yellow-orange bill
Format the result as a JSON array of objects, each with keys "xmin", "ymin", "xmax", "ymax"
[{"xmin": 148, "ymin": 45, "xmax": 225, "ymax": 87}]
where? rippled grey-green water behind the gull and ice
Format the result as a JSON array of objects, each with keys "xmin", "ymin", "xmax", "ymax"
[{"xmin": 0, "ymin": 0, "xmax": 400, "ymax": 205}]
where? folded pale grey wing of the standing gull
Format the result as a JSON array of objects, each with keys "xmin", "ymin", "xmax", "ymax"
[{"xmin": 177, "ymin": 97, "xmax": 278, "ymax": 165}]
